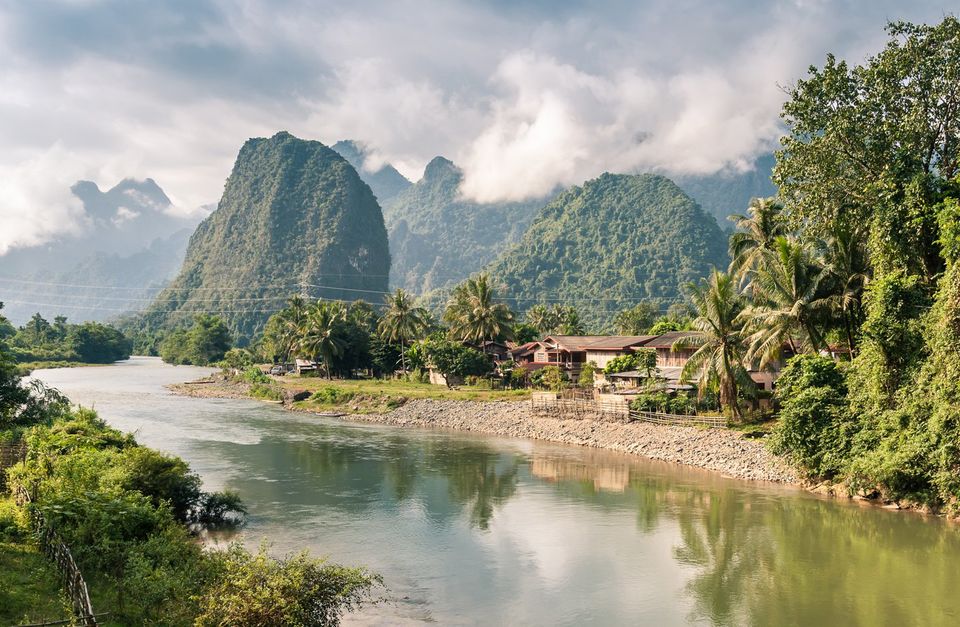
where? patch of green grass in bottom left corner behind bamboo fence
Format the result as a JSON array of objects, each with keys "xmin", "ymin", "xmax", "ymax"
[{"xmin": 0, "ymin": 542, "xmax": 72, "ymax": 625}]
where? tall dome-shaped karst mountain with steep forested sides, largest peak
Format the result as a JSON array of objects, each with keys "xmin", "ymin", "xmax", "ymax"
[{"xmin": 143, "ymin": 132, "xmax": 390, "ymax": 342}]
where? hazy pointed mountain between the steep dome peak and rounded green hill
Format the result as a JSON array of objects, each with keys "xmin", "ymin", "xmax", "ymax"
[{"xmin": 384, "ymin": 157, "xmax": 546, "ymax": 294}]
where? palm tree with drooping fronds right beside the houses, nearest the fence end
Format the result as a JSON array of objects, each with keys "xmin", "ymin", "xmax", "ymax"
[{"xmin": 673, "ymin": 270, "xmax": 754, "ymax": 418}]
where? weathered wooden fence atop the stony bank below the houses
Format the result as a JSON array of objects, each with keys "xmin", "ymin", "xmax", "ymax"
[{"xmin": 530, "ymin": 391, "xmax": 727, "ymax": 427}]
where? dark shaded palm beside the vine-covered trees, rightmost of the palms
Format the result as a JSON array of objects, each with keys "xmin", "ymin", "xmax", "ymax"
[{"xmin": 823, "ymin": 223, "xmax": 870, "ymax": 358}]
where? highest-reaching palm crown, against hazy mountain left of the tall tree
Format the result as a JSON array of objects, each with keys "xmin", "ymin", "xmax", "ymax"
[{"xmin": 729, "ymin": 198, "xmax": 787, "ymax": 280}]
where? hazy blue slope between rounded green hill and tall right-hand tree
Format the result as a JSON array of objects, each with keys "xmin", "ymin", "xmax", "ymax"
[{"xmin": 671, "ymin": 154, "xmax": 777, "ymax": 231}]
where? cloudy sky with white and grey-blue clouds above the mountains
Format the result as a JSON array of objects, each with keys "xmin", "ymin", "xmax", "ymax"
[{"xmin": 0, "ymin": 0, "xmax": 957, "ymax": 254}]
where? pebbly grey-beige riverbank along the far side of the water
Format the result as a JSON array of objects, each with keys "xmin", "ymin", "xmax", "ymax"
[{"xmin": 169, "ymin": 377, "xmax": 800, "ymax": 484}]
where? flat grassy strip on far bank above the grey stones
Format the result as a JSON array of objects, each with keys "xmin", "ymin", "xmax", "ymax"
[{"xmin": 275, "ymin": 375, "xmax": 530, "ymax": 413}]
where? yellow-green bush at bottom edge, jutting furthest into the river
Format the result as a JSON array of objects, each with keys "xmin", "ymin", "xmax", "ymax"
[{"xmin": 196, "ymin": 545, "xmax": 382, "ymax": 627}]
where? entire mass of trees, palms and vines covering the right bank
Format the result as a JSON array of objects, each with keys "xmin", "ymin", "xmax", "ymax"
[{"xmin": 704, "ymin": 17, "xmax": 960, "ymax": 510}]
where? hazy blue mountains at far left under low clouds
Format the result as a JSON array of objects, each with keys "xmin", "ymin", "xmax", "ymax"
[{"xmin": 0, "ymin": 179, "xmax": 197, "ymax": 324}]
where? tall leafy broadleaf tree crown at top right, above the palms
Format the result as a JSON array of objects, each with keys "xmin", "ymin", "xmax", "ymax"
[{"xmin": 774, "ymin": 16, "xmax": 960, "ymax": 284}]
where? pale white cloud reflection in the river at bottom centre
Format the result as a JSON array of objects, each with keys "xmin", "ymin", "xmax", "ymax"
[{"xmin": 479, "ymin": 494, "xmax": 689, "ymax": 624}]
